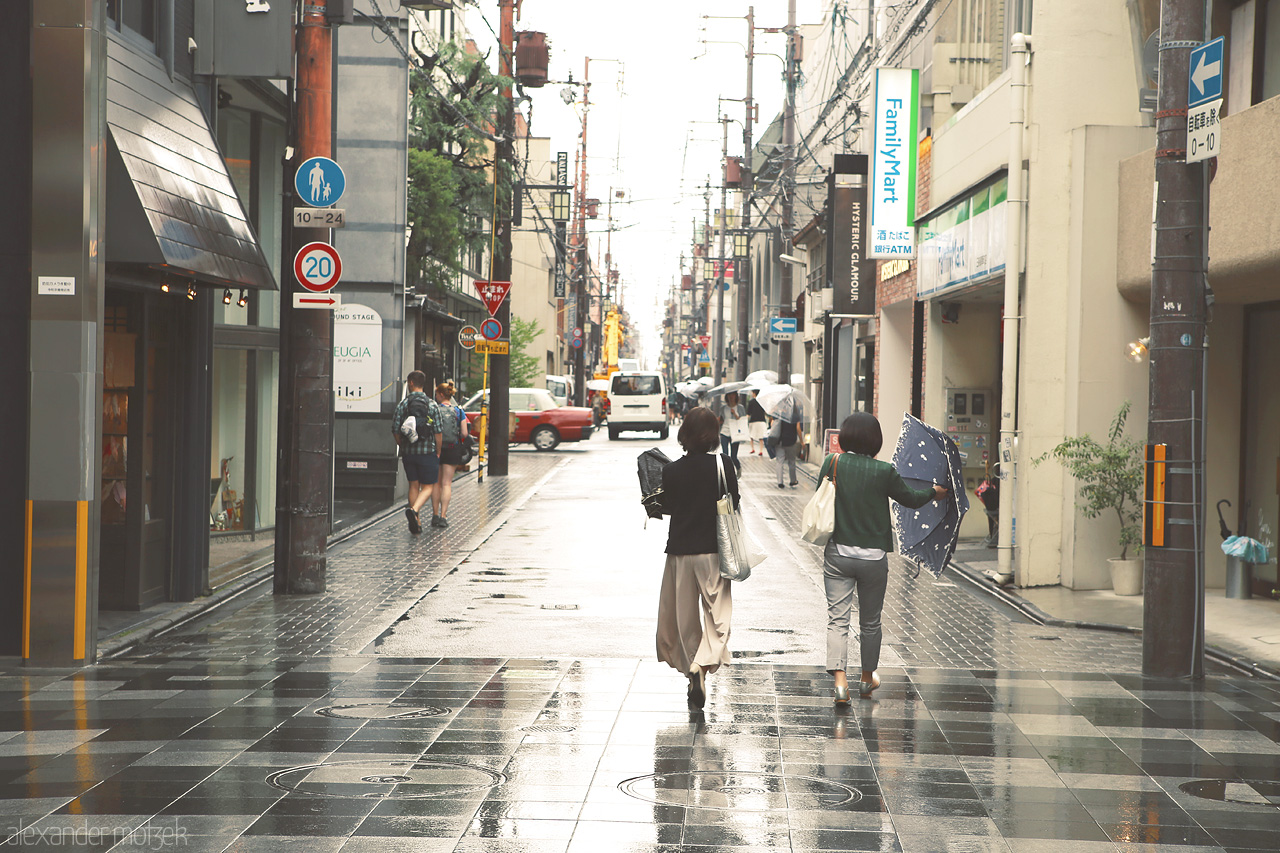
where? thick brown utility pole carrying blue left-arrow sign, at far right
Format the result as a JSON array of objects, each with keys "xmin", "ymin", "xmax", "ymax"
[{"xmin": 1142, "ymin": 0, "xmax": 1208, "ymax": 679}]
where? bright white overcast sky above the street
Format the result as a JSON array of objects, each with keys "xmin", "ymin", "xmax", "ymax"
[{"xmin": 465, "ymin": 0, "xmax": 826, "ymax": 368}]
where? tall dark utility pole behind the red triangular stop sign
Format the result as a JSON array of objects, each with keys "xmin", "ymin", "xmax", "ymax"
[{"xmin": 489, "ymin": 0, "xmax": 516, "ymax": 476}]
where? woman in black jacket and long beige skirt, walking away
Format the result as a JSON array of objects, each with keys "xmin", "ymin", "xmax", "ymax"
[{"xmin": 657, "ymin": 406, "xmax": 739, "ymax": 708}]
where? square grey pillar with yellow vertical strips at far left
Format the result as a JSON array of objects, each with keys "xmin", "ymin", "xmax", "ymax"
[{"xmin": 24, "ymin": 0, "xmax": 106, "ymax": 666}]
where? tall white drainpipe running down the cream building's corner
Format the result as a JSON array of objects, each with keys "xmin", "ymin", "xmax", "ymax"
[{"xmin": 996, "ymin": 32, "xmax": 1032, "ymax": 584}]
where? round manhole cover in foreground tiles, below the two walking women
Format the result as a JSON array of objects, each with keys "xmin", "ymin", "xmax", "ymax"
[{"xmin": 618, "ymin": 770, "xmax": 863, "ymax": 812}]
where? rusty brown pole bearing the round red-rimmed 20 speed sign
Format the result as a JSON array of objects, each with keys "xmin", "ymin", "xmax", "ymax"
[{"xmin": 274, "ymin": 0, "xmax": 333, "ymax": 594}]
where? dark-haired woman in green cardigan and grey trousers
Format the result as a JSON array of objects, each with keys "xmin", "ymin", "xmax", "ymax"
[{"xmin": 818, "ymin": 411, "xmax": 948, "ymax": 704}]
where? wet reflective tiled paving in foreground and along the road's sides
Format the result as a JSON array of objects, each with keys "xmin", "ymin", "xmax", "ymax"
[{"xmin": 0, "ymin": 442, "xmax": 1280, "ymax": 853}]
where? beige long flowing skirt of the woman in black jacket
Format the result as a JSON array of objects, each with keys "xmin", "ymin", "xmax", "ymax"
[{"xmin": 658, "ymin": 553, "xmax": 733, "ymax": 674}]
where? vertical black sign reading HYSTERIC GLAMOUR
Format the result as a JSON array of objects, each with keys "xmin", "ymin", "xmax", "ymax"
[{"xmin": 827, "ymin": 154, "xmax": 876, "ymax": 315}]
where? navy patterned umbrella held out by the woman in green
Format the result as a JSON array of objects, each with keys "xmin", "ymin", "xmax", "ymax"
[{"xmin": 893, "ymin": 414, "xmax": 969, "ymax": 578}]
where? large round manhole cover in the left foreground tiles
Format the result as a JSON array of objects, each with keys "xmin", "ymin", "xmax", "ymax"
[{"xmin": 266, "ymin": 761, "xmax": 507, "ymax": 799}]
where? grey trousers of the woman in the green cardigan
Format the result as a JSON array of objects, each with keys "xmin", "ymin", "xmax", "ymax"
[{"xmin": 822, "ymin": 540, "xmax": 888, "ymax": 672}]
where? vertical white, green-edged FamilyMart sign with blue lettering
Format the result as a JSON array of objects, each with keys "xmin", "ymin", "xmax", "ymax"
[{"xmin": 867, "ymin": 68, "xmax": 920, "ymax": 257}]
